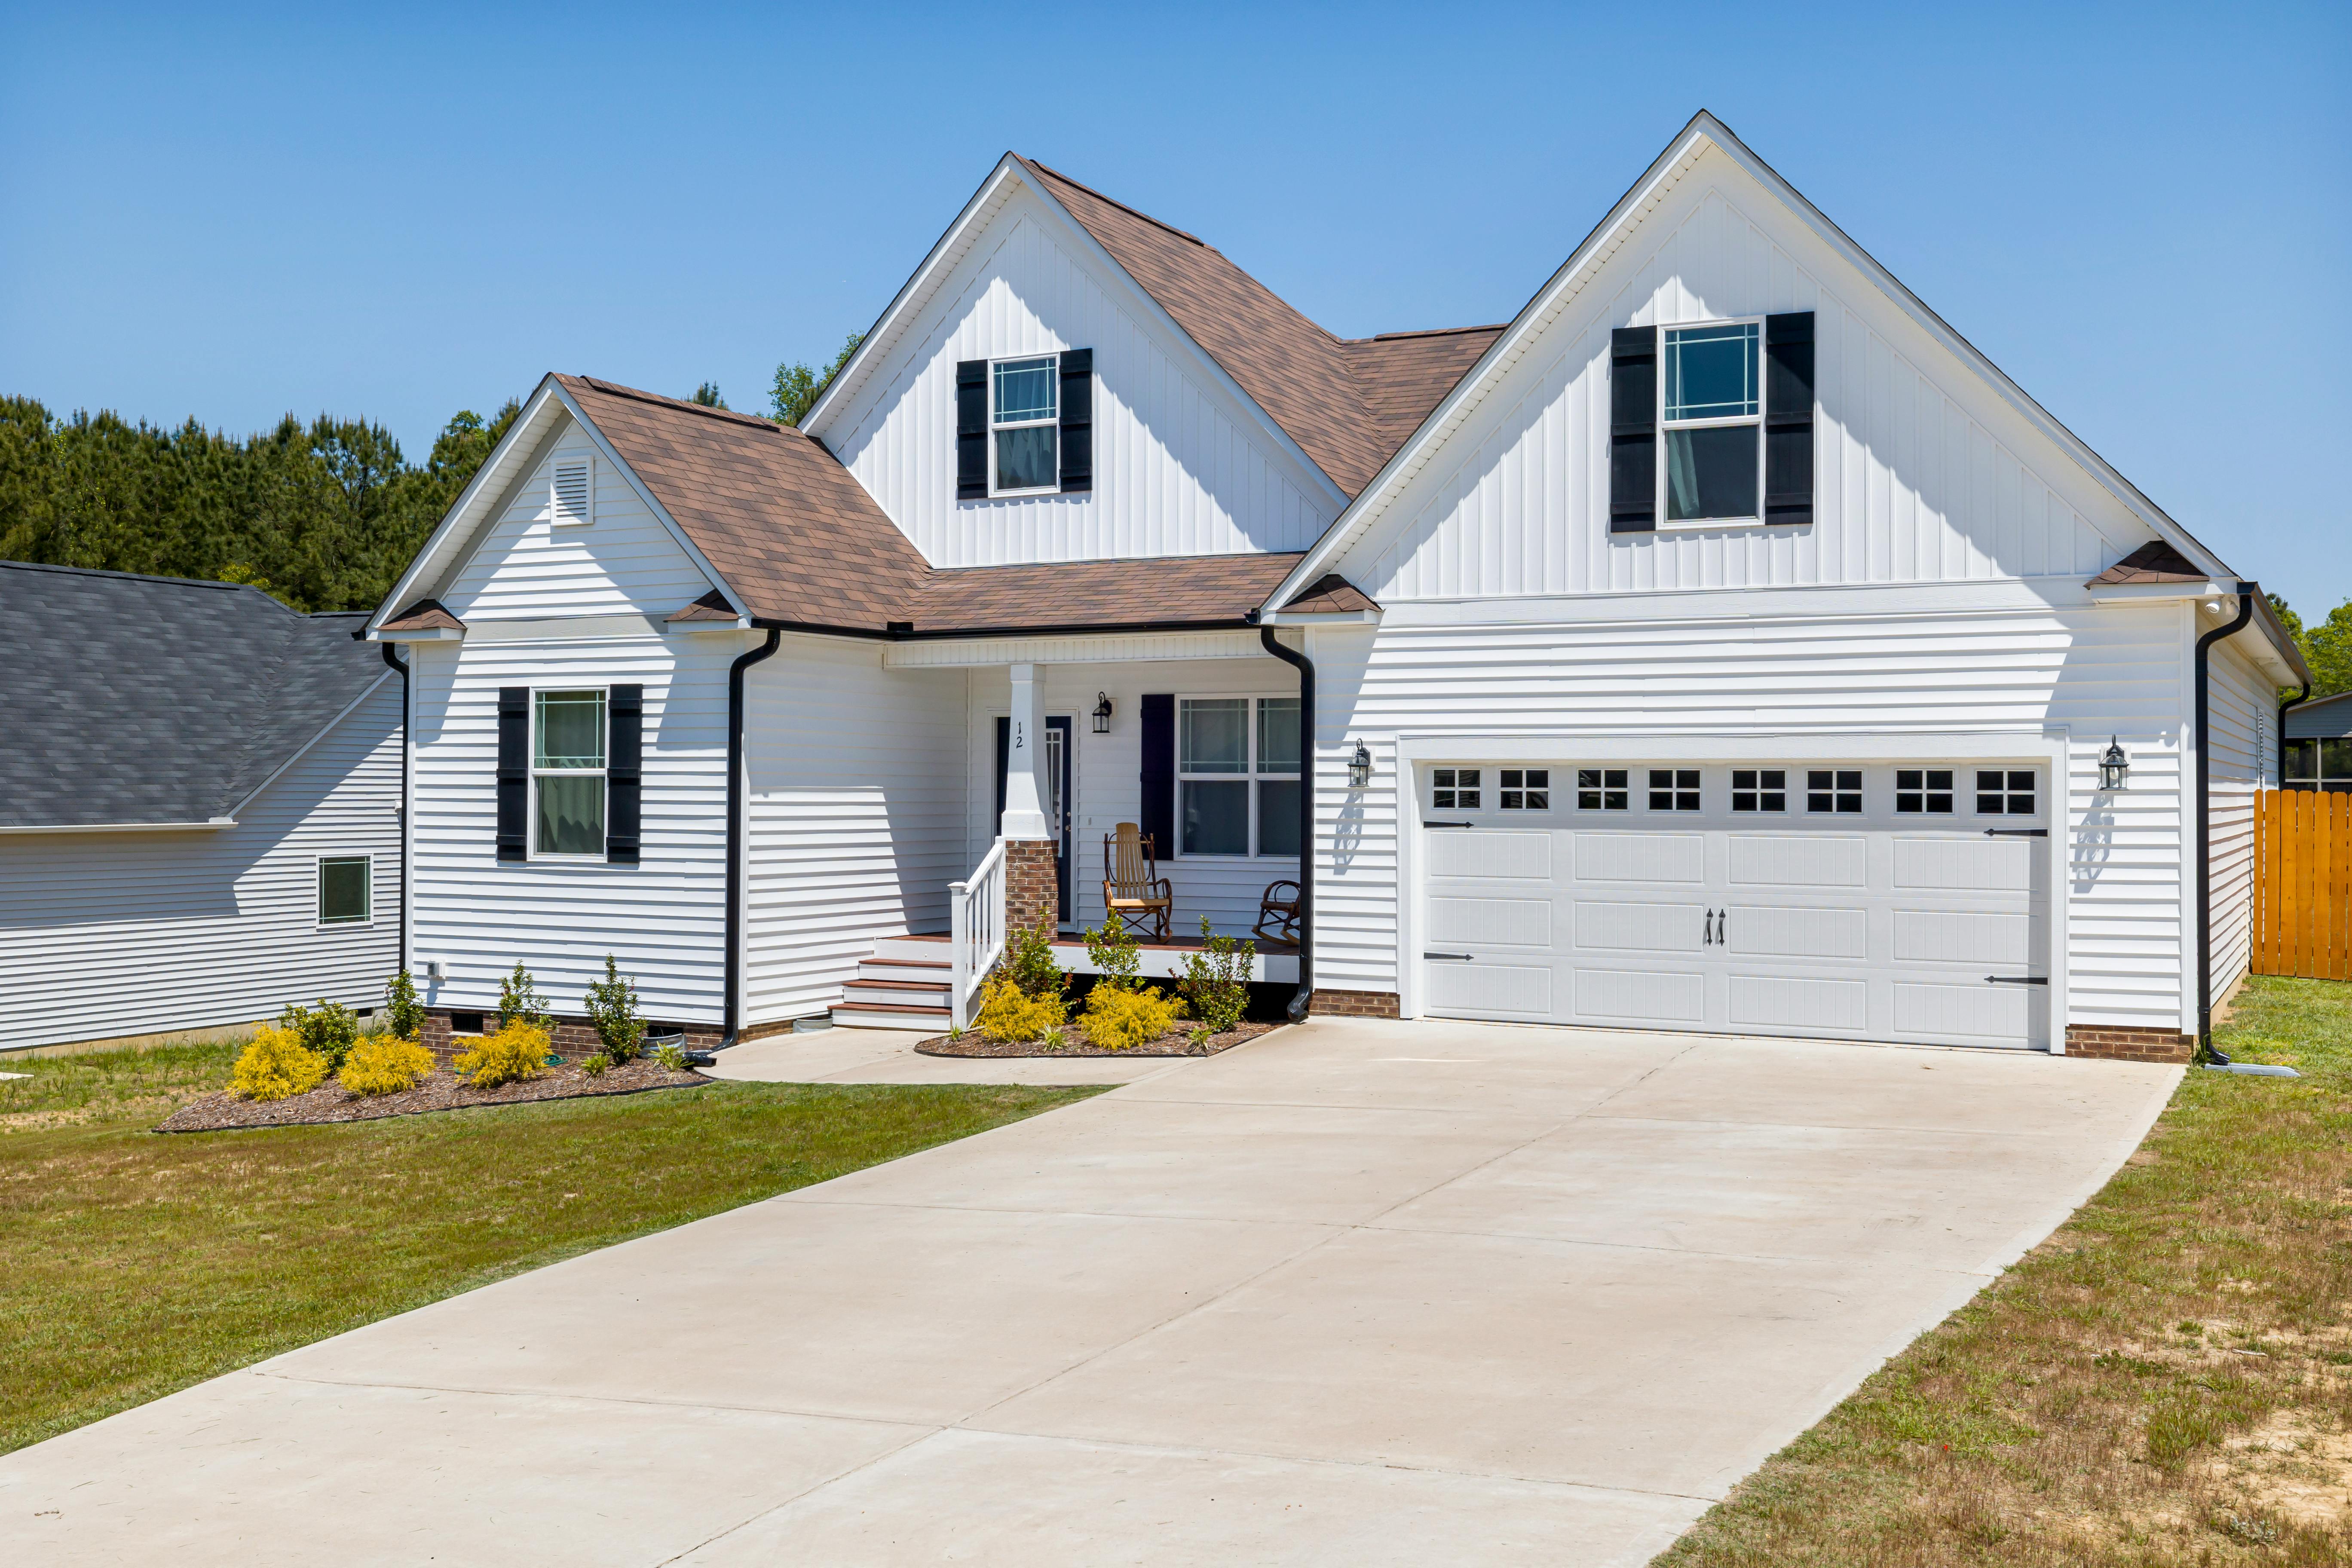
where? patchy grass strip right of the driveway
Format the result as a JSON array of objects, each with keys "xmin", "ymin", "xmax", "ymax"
[{"xmin": 1658, "ymin": 978, "xmax": 2352, "ymax": 1568}]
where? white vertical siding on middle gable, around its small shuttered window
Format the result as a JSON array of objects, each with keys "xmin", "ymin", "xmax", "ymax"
[{"xmin": 814, "ymin": 188, "xmax": 1338, "ymax": 567}]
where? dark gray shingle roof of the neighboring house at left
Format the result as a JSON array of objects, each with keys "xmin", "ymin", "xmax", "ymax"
[{"xmin": 0, "ymin": 562, "xmax": 388, "ymax": 827}]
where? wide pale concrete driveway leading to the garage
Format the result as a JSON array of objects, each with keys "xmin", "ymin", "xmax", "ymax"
[{"xmin": 0, "ymin": 1020, "xmax": 2180, "ymax": 1566}]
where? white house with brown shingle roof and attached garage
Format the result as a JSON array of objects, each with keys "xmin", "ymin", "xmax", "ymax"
[{"xmin": 369, "ymin": 115, "xmax": 2300, "ymax": 1056}]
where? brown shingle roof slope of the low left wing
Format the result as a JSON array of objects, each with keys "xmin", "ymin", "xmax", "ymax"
[{"xmin": 557, "ymin": 376, "xmax": 929, "ymax": 632}]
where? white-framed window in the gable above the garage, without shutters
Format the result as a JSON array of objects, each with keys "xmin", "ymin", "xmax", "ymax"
[{"xmin": 1658, "ymin": 320, "xmax": 1764, "ymax": 527}]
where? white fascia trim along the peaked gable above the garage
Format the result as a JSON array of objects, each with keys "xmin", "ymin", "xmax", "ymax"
[{"xmin": 1265, "ymin": 110, "xmax": 2237, "ymax": 609}]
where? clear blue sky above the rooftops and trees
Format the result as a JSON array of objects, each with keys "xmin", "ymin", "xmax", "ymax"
[{"xmin": 0, "ymin": 2, "xmax": 2352, "ymax": 616}]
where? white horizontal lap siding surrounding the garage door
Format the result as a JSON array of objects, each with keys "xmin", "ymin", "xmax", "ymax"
[{"xmin": 1310, "ymin": 588, "xmax": 2187, "ymax": 1030}]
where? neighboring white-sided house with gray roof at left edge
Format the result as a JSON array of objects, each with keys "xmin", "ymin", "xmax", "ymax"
[{"xmin": 0, "ymin": 562, "xmax": 402, "ymax": 1051}]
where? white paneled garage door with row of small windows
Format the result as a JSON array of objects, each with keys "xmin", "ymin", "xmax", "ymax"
[{"xmin": 1418, "ymin": 760, "xmax": 2049, "ymax": 1046}]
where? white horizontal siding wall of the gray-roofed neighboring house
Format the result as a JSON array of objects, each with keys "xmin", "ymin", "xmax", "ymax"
[{"xmin": 0, "ymin": 672, "xmax": 400, "ymax": 1051}]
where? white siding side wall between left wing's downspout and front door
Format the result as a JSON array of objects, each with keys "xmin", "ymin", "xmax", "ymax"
[{"xmin": 743, "ymin": 637, "xmax": 971, "ymax": 1023}]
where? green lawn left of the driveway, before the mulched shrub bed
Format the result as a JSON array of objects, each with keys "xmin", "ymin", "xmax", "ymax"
[{"xmin": 0, "ymin": 1046, "xmax": 1098, "ymax": 1453}]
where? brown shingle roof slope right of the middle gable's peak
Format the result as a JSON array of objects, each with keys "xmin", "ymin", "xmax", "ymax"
[{"xmin": 1021, "ymin": 157, "xmax": 1503, "ymax": 496}]
